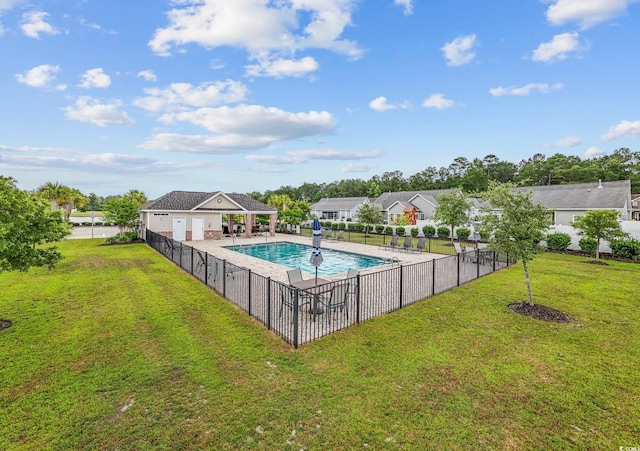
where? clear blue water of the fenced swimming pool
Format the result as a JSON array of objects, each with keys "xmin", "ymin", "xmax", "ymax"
[{"xmin": 226, "ymin": 242, "xmax": 388, "ymax": 276}]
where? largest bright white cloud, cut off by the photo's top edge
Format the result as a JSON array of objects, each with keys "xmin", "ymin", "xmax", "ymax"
[{"xmin": 149, "ymin": 0, "xmax": 363, "ymax": 76}]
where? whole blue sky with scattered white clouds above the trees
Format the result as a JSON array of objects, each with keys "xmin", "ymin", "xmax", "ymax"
[{"xmin": 0, "ymin": 0, "xmax": 640, "ymax": 198}]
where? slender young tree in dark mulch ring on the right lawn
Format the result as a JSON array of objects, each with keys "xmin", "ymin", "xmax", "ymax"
[{"xmin": 480, "ymin": 182, "xmax": 553, "ymax": 306}]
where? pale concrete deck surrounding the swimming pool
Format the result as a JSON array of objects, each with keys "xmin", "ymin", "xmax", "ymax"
[{"xmin": 185, "ymin": 233, "xmax": 447, "ymax": 283}]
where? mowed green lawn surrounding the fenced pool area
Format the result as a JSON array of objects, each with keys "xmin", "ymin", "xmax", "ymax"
[{"xmin": 0, "ymin": 240, "xmax": 640, "ymax": 450}]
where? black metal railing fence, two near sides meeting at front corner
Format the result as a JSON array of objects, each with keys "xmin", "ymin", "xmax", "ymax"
[{"xmin": 146, "ymin": 230, "xmax": 514, "ymax": 348}]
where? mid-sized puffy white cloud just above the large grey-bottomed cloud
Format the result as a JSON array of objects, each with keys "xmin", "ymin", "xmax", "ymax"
[{"xmin": 133, "ymin": 80, "xmax": 249, "ymax": 112}]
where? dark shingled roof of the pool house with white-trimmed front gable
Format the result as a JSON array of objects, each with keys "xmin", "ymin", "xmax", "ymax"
[{"xmin": 140, "ymin": 191, "xmax": 277, "ymax": 213}]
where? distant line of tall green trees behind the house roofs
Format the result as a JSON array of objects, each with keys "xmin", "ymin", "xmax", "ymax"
[{"xmin": 248, "ymin": 148, "xmax": 640, "ymax": 203}]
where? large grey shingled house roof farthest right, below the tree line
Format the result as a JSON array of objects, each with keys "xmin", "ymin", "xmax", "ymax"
[{"xmin": 516, "ymin": 180, "xmax": 631, "ymax": 210}]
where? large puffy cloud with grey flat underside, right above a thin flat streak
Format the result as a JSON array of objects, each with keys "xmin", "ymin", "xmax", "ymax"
[{"xmin": 160, "ymin": 105, "xmax": 337, "ymax": 141}]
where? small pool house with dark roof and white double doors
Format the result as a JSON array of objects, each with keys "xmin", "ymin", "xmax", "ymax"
[{"xmin": 140, "ymin": 191, "xmax": 278, "ymax": 241}]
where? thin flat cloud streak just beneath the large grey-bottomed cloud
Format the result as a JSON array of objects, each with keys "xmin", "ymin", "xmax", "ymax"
[{"xmin": 139, "ymin": 133, "xmax": 273, "ymax": 154}]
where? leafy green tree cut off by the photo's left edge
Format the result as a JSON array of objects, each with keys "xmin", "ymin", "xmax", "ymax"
[{"xmin": 0, "ymin": 176, "xmax": 69, "ymax": 272}]
